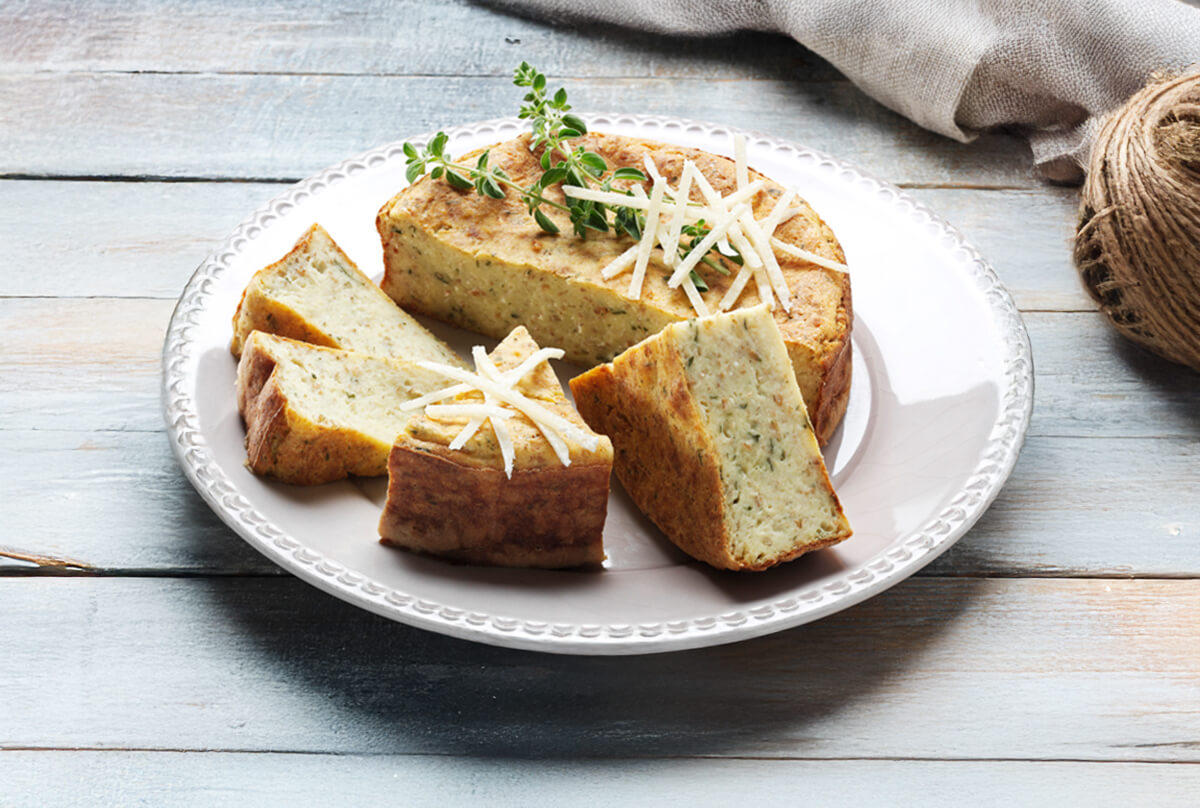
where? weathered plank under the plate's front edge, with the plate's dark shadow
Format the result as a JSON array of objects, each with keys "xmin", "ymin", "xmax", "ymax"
[{"xmin": 0, "ymin": 577, "xmax": 1200, "ymax": 762}]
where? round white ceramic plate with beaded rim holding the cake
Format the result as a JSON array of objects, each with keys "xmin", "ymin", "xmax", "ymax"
[{"xmin": 163, "ymin": 115, "xmax": 1032, "ymax": 654}]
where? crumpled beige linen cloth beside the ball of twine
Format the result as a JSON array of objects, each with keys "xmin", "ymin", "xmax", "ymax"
[{"xmin": 497, "ymin": 0, "xmax": 1200, "ymax": 181}]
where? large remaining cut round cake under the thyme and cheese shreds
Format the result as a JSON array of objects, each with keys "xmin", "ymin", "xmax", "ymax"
[{"xmin": 376, "ymin": 133, "xmax": 852, "ymax": 442}]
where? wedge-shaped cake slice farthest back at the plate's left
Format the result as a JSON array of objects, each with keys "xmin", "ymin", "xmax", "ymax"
[{"xmin": 230, "ymin": 225, "xmax": 462, "ymax": 364}]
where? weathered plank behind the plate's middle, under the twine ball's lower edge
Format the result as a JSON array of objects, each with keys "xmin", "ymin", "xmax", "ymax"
[{"xmin": 0, "ymin": 298, "xmax": 1200, "ymax": 441}]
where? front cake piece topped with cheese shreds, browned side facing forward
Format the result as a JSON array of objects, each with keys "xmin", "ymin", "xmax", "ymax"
[{"xmin": 379, "ymin": 327, "xmax": 612, "ymax": 568}]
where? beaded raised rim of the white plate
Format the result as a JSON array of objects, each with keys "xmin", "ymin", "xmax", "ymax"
[{"xmin": 161, "ymin": 113, "xmax": 1033, "ymax": 656}]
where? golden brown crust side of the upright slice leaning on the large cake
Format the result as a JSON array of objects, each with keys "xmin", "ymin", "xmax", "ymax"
[{"xmin": 571, "ymin": 340, "xmax": 739, "ymax": 569}]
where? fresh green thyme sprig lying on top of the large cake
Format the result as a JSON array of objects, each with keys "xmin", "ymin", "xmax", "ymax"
[{"xmin": 403, "ymin": 61, "xmax": 742, "ymax": 292}]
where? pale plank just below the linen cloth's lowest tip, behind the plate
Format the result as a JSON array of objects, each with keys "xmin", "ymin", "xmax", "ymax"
[{"xmin": 0, "ymin": 180, "xmax": 1094, "ymax": 311}]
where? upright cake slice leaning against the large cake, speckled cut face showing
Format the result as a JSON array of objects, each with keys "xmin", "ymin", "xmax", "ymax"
[{"xmin": 571, "ymin": 306, "xmax": 851, "ymax": 570}]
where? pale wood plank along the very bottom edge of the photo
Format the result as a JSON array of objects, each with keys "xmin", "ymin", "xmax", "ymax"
[{"xmin": 0, "ymin": 752, "xmax": 1200, "ymax": 808}]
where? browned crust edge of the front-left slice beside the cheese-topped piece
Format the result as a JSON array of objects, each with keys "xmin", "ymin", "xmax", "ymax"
[{"xmin": 230, "ymin": 339, "xmax": 386, "ymax": 485}]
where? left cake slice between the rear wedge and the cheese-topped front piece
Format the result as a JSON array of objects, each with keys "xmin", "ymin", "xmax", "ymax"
[{"xmin": 238, "ymin": 331, "xmax": 445, "ymax": 485}]
